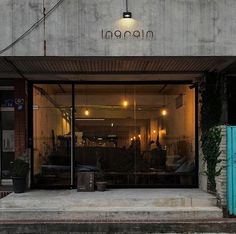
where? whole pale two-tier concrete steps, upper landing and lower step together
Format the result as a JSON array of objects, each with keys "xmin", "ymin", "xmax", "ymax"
[{"xmin": 0, "ymin": 190, "xmax": 223, "ymax": 221}]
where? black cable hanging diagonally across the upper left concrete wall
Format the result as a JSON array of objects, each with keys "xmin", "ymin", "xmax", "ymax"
[{"xmin": 0, "ymin": 0, "xmax": 65, "ymax": 54}]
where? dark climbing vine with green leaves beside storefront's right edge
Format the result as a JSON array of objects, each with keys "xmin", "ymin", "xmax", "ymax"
[{"xmin": 200, "ymin": 73, "xmax": 222, "ymax": 192}]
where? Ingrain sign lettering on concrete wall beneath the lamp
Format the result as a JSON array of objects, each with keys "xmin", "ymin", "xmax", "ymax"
[{"xmin": 101, "ymin": 29, "xmax": 154, "ymax": 40}]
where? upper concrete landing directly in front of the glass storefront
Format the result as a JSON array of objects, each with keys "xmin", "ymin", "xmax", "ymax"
[{"xmin": 0, "ymin": 189, "xmax": 217, "ymax": 209}]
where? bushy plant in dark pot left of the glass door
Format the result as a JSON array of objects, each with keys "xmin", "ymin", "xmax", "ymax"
[{"xmin": 11, "ymin": 158, "xmax": 29, "ymax": 193}]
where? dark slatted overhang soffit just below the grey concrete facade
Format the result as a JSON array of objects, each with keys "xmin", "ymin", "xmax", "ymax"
[{"xmin": 0, "ymin": 57, "xmax": 236, "ymax": 80}]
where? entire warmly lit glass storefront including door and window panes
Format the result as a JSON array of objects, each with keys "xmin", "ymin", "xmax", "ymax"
[{"xmin": 32, "ymin": 82, "xmax": 197, "ymax": 188}]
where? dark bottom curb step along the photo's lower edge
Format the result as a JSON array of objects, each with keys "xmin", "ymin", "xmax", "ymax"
[{"xmin": 0, "ymin": 219, "xmax": 236, "ymax": 234}]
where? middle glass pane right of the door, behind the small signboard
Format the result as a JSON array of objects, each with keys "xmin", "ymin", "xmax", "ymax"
[{"xmin": 75, "ymin": 85, "xmax": 136, "ymax": 186}]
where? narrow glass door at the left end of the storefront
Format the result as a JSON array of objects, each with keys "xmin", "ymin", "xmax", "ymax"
[{"xmin": 33, "ymin": 84, "xmax": 73, "ymax": 188}]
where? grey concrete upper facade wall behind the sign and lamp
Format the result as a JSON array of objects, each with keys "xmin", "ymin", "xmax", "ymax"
[{"xmin": 0, "ymin": 0, "xmax": 236, "ymax": 56}]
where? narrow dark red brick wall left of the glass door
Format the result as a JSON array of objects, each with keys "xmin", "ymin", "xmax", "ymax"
[{"xmin": 15, "ymin": 80, "xmax": 27, "ymax": 158}]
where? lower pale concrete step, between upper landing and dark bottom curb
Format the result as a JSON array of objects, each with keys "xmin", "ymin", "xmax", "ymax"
[{"xmin": 0, "ymin": 207, "xmax": 223, "ymax": 221}]
